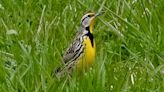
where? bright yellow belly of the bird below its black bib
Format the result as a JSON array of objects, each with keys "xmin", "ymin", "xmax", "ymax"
[{"xmin": 77, "ymin": 37, "xmax": 96, "ymax": 70}]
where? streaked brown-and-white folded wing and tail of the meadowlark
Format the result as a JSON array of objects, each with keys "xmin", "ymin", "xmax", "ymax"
[{"xmin": 55, "ymin": 39, "xmax": 82, "ymax": 79}]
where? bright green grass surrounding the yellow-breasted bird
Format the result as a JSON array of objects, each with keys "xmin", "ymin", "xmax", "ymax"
[{"xmin": 0, "ymin": 0, "xmax": 164, "ymax": 92}]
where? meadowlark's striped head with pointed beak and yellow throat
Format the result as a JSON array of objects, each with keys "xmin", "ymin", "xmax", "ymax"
[{"xmin": 81, "ymin": 13, "xmax": 100, "ymax": 33}]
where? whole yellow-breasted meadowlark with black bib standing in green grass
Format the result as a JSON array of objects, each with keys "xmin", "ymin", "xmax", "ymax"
[{"xmin": 55, "ymin": 13, "xmax": 100, "ymax": 77}]
